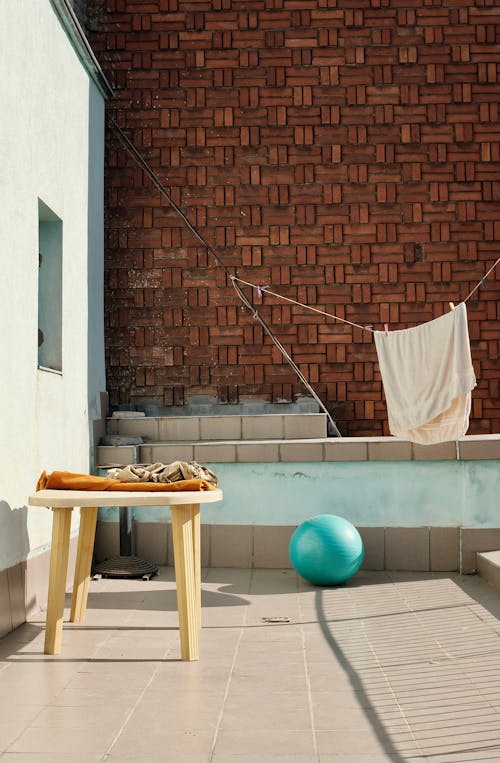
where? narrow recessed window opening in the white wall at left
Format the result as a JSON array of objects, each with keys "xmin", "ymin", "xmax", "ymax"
[{"xmin": 38, "ymin": 199, "xmax": 62, "ymax": 371}]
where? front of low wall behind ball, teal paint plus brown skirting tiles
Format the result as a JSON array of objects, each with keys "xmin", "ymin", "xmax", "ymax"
[{"xmin": 96, "ymin": 448, "xmax": 500, "ymax": 572}]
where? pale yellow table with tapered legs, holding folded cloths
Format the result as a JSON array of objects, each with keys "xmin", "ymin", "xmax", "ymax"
[{"xmin": 28, "ymin": 489, "xmax": 222, "ymax": 660}]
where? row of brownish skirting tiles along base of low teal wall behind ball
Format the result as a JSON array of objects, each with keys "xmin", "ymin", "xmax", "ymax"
[{"xmin": 95, "ymin": 522, "xmax": 500, "ymax": 574}]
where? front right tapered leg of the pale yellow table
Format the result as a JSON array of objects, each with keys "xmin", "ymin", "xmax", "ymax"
[{"xmin": 172, "ymin": 504, "xmax": 199, "ymax": 660}]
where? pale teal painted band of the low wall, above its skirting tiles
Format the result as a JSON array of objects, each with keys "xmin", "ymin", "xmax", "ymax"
[{"xmin": 100, "ymin": 461, "xmax": 500, "ymax": 527}]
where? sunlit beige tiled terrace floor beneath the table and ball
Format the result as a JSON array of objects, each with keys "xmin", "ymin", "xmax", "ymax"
[{"xmin": 0, "ymin": 569, "xmax": 500, "ymax": 763}]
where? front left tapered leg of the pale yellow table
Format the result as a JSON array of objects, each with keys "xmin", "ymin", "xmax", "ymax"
[{"xmin": 44, "ymin": 507, "xmax": 73, "ymax": 654}]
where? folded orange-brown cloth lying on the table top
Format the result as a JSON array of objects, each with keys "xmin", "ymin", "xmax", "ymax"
[{"xmin": 36, "ymin": 471, "xmax": 215, "ymax": 493}]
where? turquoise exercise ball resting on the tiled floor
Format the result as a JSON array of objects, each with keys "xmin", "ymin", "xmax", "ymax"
[{"xmin": 288, "ymin": 514, "xmax": 364, "ymax": 585}]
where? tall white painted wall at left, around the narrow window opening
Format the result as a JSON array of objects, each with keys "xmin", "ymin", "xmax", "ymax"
[{"xmin": 0, "ymin": 0, "xmax": 105, "ymax": 570}]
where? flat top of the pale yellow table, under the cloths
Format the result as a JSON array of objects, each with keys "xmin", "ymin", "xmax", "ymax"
[{"xmin": 28, "ymin": 488, "xmax": 222, "ymax": 509}]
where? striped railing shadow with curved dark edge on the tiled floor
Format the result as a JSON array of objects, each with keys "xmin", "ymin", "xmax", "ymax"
[{"xmin": 315, "ymin": 573, "xmax": 500, "ymax": 763}]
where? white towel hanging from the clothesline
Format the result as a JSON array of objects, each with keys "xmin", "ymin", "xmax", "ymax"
[{"xmin": 374, "ymin": 302, "xmax": 476, "ymax": 445}]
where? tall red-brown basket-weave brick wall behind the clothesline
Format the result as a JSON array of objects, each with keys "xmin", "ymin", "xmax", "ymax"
[{"xmin": 90, "ymin": 0, "xmax": 500, "ymax": 435}]
